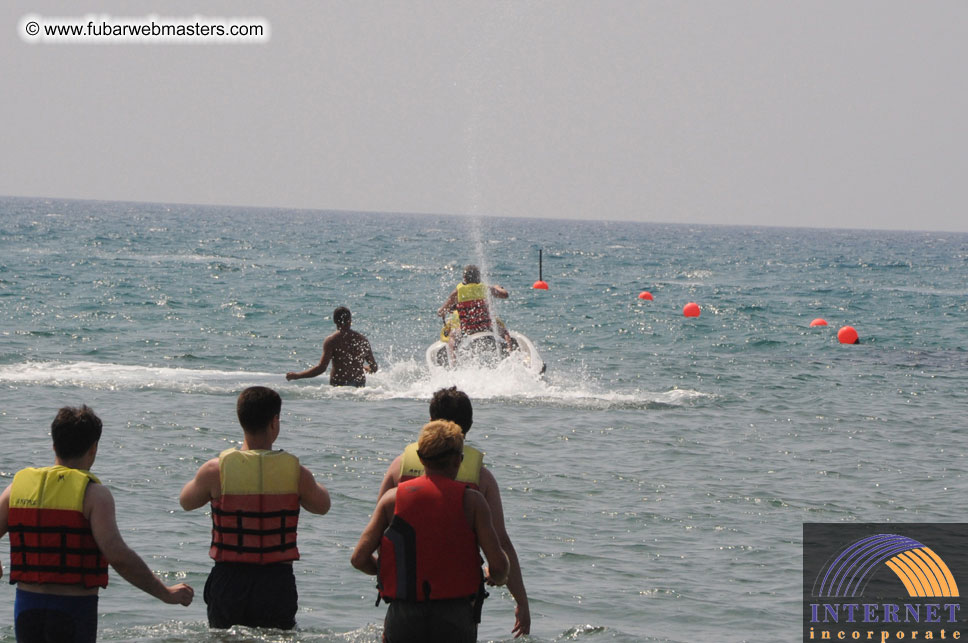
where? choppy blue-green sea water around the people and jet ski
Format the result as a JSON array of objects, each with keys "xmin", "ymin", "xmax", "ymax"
[{"xmin": 0, "ymin": 198, "xmax": 968, "ymax": 642}]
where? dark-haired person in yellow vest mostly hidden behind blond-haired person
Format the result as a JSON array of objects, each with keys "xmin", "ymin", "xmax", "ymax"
[{"xmin": 378, "ymin": 386, "xmax": 531, "ymax": 638}]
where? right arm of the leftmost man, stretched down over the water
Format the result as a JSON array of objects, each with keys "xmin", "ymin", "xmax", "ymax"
[{"xmin": 84, "ymin": 483, "xmax": 195, "ymax": 606}]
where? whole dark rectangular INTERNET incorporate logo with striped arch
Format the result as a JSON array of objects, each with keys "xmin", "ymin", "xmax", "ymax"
[{"xmin": 803, "ymin": 523, "xmax": 968, "ymax": 643}]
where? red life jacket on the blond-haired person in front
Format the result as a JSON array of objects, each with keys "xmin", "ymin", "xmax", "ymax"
[{"xmin": 378, "ymin": 475, "xmax": 484, "ymax": 602}]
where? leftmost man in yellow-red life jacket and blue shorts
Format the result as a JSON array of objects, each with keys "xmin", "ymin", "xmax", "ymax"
[{"xmin": 0, "ymin": 406, "xmax": 195, "ymax": 642}]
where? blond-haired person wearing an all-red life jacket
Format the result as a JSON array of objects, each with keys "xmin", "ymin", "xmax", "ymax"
[{"xmin": 350, "ymin": 420, "xmax": 509, "ymax": 643}]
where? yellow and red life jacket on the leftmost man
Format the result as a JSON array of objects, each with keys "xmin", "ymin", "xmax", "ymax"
[{"xmin": 7, "ymin": 465, "xmax": 108, "ymax": 588}]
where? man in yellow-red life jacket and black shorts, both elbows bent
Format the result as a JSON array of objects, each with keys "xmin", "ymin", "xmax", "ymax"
[{"xmin": 179, "ymin": 386, "xmax": 330, "ymax": 630}]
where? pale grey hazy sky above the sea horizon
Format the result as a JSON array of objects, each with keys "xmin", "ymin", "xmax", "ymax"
[{"xmin": 0, "ymin": 0, "xmax": 968, "ymax": 231}]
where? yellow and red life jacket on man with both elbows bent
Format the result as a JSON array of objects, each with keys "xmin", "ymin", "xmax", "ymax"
[{"xmin": 208, "ymin": 449, "xmax": 300, "ymax": 565}]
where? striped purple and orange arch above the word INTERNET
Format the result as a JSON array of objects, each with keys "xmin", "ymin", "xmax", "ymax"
[{"xmin": 813, "ymin": 534, "xmax": 960, "ymax": 598}]
